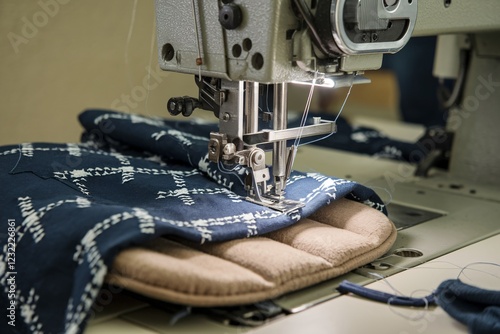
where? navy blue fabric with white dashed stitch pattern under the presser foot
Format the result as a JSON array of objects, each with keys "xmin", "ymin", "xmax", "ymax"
[{"xmin": 0, "ymin": 110, "xmax": 385, "ymax": 333}]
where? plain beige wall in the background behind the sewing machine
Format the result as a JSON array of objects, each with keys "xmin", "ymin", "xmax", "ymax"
[{"xmin": 0, "ymin": 0, "xmax": 397, "ymax": 145}]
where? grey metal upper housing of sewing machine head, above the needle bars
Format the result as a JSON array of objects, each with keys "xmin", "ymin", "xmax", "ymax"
[{"xmin": 156, "ymin": 0, "xmax": 418, "ymax": 83}]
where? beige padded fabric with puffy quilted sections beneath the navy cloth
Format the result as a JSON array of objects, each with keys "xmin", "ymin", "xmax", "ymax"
[{"xmin": 107, "ymin": 199, "xmax": 396, "ymax": 306}]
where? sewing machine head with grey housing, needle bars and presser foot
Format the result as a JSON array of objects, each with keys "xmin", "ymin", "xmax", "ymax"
[{"xmin": 156, "ymin": 0, "xmax": 417, "ymax": 211}]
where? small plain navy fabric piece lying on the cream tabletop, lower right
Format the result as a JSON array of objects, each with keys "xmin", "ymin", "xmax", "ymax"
[{"xmin": 436, "ymin": 279, "xmax": 500, "ymax": 334}]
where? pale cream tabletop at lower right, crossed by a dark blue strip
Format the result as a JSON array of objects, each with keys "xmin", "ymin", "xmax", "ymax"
[{"xmin": 252, "ymin": 235, "xmax": 500, "ymax": 334}]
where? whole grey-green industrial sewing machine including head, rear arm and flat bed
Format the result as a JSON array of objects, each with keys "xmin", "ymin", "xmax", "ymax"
[{"xmin": 84, "ymin": 0, "xmax": 500, "ymax": 332}]
